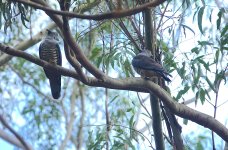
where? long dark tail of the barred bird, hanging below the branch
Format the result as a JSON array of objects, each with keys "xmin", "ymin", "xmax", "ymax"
[{"xmin": 49, "ymin": 76, "xmax": 61, "ymax": 99}]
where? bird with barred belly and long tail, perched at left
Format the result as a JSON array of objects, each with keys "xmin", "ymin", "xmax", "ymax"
[{"xmin": 39, "ymin": 30, "xmax": 62, "ymax": 99}]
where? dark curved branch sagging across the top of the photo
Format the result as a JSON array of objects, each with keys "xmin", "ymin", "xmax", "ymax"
[{"xmin": 13, "ymin": 0, "xmax": 166, "ymax": 21}]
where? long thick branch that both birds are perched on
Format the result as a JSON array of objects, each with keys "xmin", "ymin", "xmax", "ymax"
[{"xmin": 0, "ymin": 43, "xmax": 228, "ymax": 142}]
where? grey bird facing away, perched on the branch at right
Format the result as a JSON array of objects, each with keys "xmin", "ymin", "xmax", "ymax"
[{"xmin": 132, "ymin": 50, "xmax": 172, "ymax": 82}]
